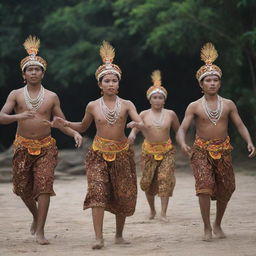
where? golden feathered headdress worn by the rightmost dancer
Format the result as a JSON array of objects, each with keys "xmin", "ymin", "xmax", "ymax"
[{"xmin": 196, "ymin": 43, "xmax": 222, "ymax": 82}]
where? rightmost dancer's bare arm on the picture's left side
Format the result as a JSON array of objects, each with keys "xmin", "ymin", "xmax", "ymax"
[{"xmin": 176, "ymin": 103, "xmax": 195, "ymax": 156}]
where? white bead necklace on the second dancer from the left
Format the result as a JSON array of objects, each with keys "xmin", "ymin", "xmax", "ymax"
[{"xmin": 100, "ymin": 96, "xmax": 122, "ymax": 125}]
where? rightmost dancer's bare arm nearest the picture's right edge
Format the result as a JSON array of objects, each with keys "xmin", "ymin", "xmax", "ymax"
[{"xmin": 229, "ymin": 101, "xmax": 255, "ymax": 157}]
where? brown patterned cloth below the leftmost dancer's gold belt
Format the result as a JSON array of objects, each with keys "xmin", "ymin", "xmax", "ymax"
[{"xmin": 13, "ymin": 137, "xmax": 58, "ymax": 199}]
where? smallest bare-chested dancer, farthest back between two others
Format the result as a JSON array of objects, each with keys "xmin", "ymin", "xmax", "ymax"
[{"xmin": 128, "ymin": 70, "xmax": 180, "ymax": 221}]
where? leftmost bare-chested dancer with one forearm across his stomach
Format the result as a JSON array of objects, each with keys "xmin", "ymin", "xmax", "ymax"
[{"xmin": 0, "ymin": 36, "xmax": 82, "ymax": 245}]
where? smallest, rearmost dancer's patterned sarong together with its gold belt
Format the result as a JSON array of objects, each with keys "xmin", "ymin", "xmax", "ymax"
[{"xmin": 140, "ymin": 139, "xmax": 176, "ymax": 197}]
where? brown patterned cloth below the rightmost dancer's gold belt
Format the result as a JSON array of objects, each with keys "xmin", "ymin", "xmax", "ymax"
[{"xmin": 191, "ymin": 136, "xmax": 235, "ymax": 202}]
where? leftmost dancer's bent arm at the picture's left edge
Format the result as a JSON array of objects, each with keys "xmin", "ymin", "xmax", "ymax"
[{"xmin": 0, "ymin": 90, "xmax": 35, "ymax": 124}]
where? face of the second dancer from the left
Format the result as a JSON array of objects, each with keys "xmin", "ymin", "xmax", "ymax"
[{"xmin": 99, "ymin": 74, "xmax": 119, "ymax": 95}]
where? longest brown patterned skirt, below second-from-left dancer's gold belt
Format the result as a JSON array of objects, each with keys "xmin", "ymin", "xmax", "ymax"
[{"xmin": 84, "ymin": 148, "xmax": 137, "ymax": 216}]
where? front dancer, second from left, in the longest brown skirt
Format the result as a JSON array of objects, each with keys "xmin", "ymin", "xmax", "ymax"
[{"xmin": 52, "ymin": 41, "xmax": 143, "ymax": 249}]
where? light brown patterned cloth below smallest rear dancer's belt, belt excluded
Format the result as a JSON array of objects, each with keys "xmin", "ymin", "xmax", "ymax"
[{"xmin": 140, "ymin": 149, "xmax": 176, "ymax": 197}]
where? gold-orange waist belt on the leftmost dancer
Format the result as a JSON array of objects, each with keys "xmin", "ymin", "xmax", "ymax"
[{"xmin": 13, "ymin": 134, "xmax": 56, "ymax": 156}]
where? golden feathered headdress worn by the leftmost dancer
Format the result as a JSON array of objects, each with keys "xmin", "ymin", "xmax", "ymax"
[{"xmin": 20, "ymin": 35, "xmax": 47, "ymax": 71}]
